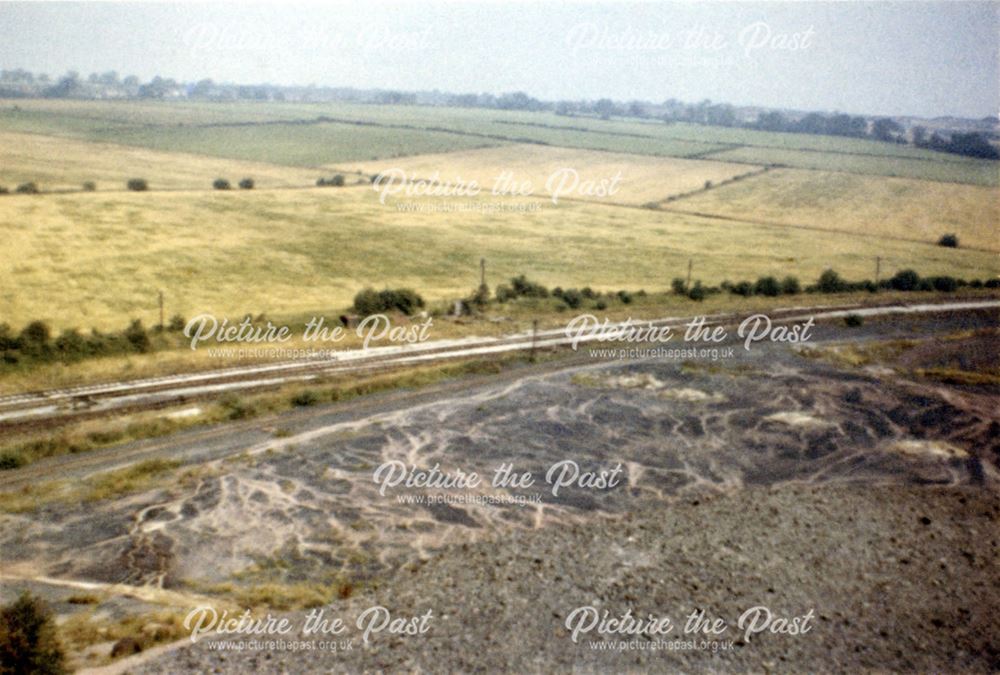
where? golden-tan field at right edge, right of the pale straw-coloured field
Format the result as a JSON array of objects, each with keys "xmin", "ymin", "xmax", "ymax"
[{"xmin": 667, "ymin": 169, "xmax": 1000, "ymax": 255}]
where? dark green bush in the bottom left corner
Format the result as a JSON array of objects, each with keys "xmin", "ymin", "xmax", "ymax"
[{"xmin": 0, "ymin": 593, "xmax": 66, "ymax": 675}]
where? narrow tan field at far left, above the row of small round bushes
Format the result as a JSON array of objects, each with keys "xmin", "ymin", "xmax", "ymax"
[{"xmin": 0, "ymin": 133, "xmax": 322, "ymax": 190}]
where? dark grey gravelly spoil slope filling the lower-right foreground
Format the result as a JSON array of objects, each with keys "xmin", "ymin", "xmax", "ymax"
[{"xmin": 135, "ymin": 484, "xmax": 1000, "ymax": 673}]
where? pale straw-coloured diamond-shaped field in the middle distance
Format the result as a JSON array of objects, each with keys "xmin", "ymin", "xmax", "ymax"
[{"xmin": 330, "ymin": 144, "xmax": 759, "ymax": 205}]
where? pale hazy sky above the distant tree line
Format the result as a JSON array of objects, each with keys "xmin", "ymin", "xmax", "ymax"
[{"xmin": 0, "ymin": 0, "xmax": 1000, "ymax": 117}]
